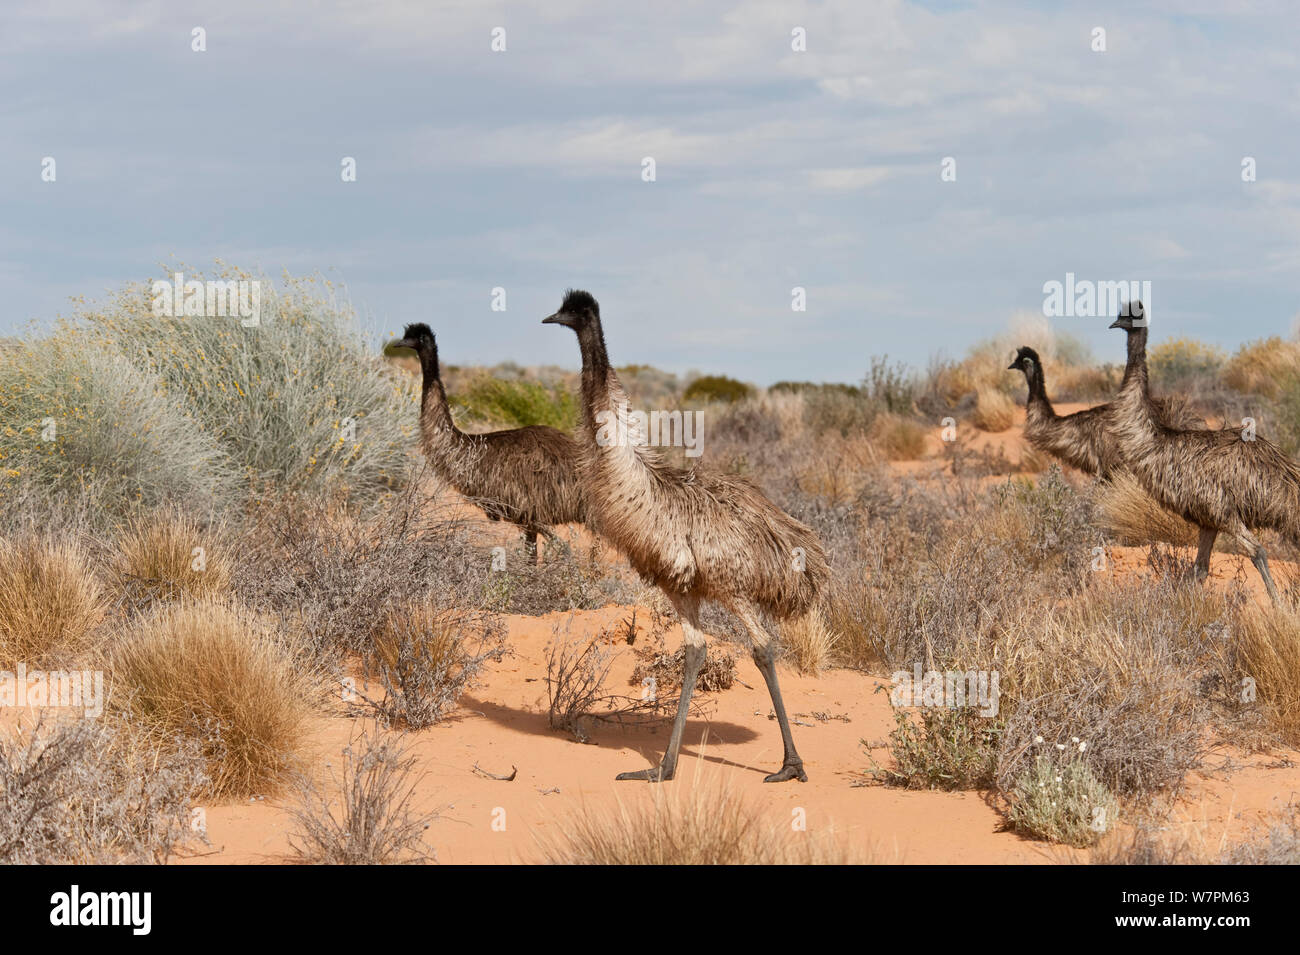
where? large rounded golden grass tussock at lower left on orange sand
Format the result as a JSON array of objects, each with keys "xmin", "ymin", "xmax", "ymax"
[{"xmin": 109, "ymin": 602, "xmax": 317, "ymax": 796}]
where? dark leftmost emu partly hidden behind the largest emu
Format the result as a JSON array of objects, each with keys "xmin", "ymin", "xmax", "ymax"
[{"xmin": 387, "ymin": 322, "xmax": 584, "ymax": 559}]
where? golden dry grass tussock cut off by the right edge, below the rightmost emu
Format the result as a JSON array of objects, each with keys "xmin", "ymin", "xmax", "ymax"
[{"xmin": 1234, "ymin": 604, "xmax": 1300, "ymax": 743}]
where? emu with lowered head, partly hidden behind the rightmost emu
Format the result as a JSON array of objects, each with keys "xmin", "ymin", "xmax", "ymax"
[{"xmin": 1009, "ymin": 346, "xmax": 1205, "ymax": 481}]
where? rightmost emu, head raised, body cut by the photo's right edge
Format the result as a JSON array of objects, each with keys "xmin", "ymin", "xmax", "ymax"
[{"xmin": 1110, "ymin": 301, "xmax": 1300, "ymax": 603}]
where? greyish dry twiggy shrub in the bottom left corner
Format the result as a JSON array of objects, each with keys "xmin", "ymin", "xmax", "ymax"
[{"xmin": 0, "ymin": 717, "xmax": 207, "ymax": 865}]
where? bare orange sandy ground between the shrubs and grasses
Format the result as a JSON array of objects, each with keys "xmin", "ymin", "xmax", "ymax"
[{"xmin": 175, "ymin": 405, "xmax": 1300, "ymax": 864}]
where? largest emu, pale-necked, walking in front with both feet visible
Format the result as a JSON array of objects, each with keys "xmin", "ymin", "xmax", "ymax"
[{"xmin": 542, "ymin": 291, "xmax": 829, "ymax": 782}]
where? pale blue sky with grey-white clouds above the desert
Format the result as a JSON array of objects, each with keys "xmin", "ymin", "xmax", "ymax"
[{"xmin": 0, "ymin": 0, "xmax": 1300, "ymax": 385}]
